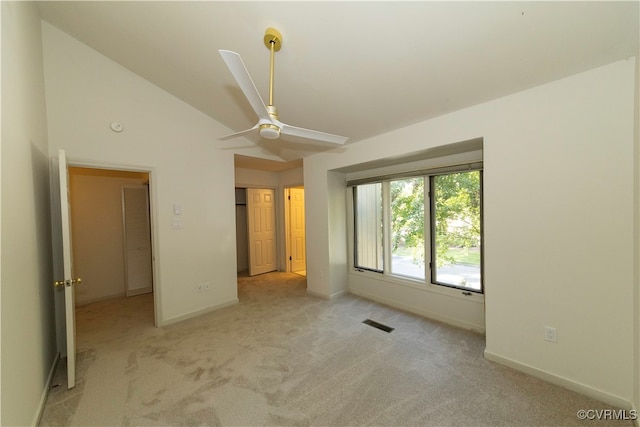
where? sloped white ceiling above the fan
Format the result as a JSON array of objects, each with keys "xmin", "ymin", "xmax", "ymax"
[{"xmin": 39, "ymin": 1, "xmax": 640, "ymax": 169}]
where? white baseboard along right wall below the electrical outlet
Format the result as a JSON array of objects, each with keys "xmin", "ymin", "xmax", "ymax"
[{"xmin": 484, "ymin": 350, "xmax": 638, "ymax": 412}]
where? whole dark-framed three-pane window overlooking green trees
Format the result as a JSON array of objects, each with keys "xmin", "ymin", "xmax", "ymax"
[{"xmin": 353, "ymin": 169, "xmax": 483, "ymax": 293}]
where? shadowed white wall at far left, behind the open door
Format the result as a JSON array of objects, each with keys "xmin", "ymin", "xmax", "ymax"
[{"xmin": 0, "ymin": 2, "xmax": 57, "ymax": 426}]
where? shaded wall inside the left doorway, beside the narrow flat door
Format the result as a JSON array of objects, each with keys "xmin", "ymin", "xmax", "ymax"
[{"xmin": 69, "ymin": 168, "xmax": 147, "ymax": 306}]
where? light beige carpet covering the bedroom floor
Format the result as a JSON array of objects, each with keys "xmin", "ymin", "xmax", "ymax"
[{"xmin": 40, "ymin": 273, "xmax": 632, "ymax": 426}]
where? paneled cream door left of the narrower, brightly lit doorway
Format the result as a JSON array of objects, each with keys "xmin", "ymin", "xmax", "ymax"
[{"xmin": 247, "ymin": 188, "xmax": 276, "ymax": 276}]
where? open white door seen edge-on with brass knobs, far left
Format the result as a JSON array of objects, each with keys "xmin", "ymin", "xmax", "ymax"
[{"xmin": 52, "ymin": 150, "xmax": 82, "ymax": 388}]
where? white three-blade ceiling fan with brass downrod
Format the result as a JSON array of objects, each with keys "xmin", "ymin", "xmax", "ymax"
[{"xmin": 218, "ymin": 28, "xmax": 349, "ymax": 144}]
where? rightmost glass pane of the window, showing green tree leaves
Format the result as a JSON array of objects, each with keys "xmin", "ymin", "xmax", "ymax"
[{"xmin": 432, "ymin": 171, "xmax": 482, "ymax": 292}]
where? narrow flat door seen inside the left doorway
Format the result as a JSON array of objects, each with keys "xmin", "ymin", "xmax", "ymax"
[{"xmin": 122, "ymin": 185, "xmax": 153, "ymax": 297}]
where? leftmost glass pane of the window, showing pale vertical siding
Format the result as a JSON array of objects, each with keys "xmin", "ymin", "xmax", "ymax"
[{"xmin": 353, "ymin": 182, "xmax": 383, "ymax": 271}]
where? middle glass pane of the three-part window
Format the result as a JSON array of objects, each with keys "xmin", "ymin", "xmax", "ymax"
[{"xmin": 390, "ymin": 177, "xmax": 425, "ymax": 279}]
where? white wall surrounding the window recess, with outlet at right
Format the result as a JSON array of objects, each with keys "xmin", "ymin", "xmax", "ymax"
[{"xmin": 304, "ymin": 58, "xmax": 638, "ymax": 406}]
